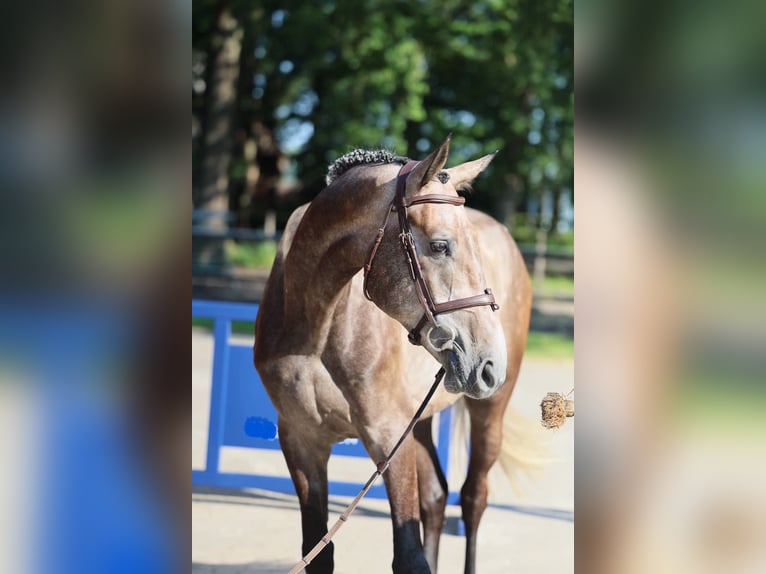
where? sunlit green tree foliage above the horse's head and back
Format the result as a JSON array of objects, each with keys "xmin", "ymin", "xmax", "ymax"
[{"xmin": 192, "ymin": 0, "xmax": 573, "ymax": 224}]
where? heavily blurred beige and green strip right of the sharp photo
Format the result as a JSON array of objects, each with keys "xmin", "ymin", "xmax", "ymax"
[{"xmin": 575, "ymin": 0, "xmax": 766, "ymax": 574}]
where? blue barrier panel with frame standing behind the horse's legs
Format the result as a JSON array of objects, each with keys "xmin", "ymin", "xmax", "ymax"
[{"xmin": 192, "ymin": 300, "xmax": 459, "ymax": 504}]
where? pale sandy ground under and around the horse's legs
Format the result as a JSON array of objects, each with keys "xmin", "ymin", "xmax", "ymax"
[{"xmin": 192, "ymin": 330, "xmax": 574, "ymax": 574}]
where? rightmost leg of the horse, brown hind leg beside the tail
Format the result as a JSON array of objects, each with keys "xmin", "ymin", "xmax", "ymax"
[{"xmin": 460, "ymin": 385, "xmax": 511, "ymax": 574}]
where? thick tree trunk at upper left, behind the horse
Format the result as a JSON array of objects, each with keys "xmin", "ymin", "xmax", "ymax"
[{"xmin": 193, "ymin": 1, "xmax": 242, "ymax": 268}]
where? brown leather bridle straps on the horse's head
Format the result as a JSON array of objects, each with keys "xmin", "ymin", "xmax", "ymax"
[{"xmin": 364, "ymin": 161, "xmax": 500, "ymax": 345}]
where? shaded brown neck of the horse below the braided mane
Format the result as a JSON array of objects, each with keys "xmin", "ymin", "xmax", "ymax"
[{"xmin": 284, "ymin": 171, "xmax": 391, "ymax": 351}]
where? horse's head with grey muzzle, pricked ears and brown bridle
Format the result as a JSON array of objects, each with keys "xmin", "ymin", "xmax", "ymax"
[{"xmin": 365, "ymin": 138, "xmax": 507, "ymax": 399}]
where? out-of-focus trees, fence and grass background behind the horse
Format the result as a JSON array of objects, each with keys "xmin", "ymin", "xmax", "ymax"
[{"xmin": 192, "ymin": 0, "xmax": 574, "ymax": 356}]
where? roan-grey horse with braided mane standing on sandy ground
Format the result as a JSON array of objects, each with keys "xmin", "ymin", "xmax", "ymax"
[{"xmin": 253, "ymin": 138, "xmax": 532, "ymax": 574}]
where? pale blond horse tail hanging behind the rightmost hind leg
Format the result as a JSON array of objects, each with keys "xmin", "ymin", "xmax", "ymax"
[{"xmin": 448, "ymin": 400, "xmax": 553, "ymax": 496}]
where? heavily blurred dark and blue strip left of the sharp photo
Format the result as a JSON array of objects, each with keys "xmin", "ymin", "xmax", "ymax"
[{"xmin": 0, "ymin": 0, "xmax": 186, "ymax": 574}]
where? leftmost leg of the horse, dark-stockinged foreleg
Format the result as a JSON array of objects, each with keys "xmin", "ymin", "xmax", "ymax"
[{"xmin": 279, "ymin": 420, "xmax": 334, "ymax": 574}]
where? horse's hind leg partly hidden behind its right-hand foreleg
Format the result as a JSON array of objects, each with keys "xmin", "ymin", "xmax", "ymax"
[{"xmin": 413, "ymin": 418, "xmax": 447, "ymax": 574}]
